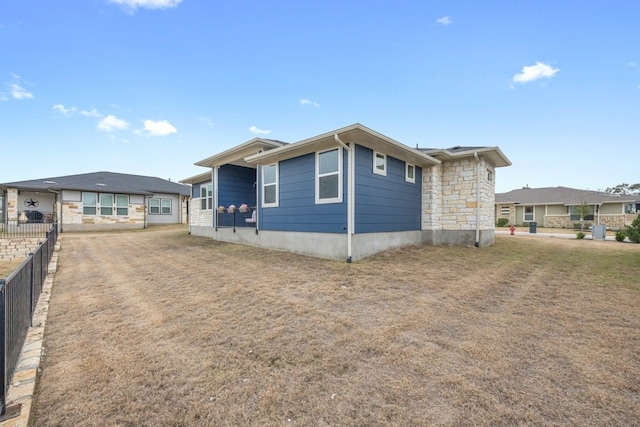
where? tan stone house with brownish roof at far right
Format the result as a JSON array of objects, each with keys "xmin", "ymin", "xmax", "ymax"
[{"xmin": 495, "ymin": 187, "xmax": 640, "ymax": 230}]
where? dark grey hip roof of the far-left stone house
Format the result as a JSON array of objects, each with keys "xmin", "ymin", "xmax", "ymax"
[{"xmin": 0, "ymin": 172, "xmax": 190, "ymax": 196}]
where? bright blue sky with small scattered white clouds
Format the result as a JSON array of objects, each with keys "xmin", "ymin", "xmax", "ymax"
[{"xmin": 0, "ymin": 0, "xmax": 640, "ymax": 192}]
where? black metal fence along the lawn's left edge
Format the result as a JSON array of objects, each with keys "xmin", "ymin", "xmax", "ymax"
[{"xmin": 0, "ymin": 223, "xmax": 58, "ymax": 415}]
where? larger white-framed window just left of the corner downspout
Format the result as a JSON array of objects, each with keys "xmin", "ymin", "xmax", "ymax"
[{"xmin": 316, "ymin": 148, "xmax": 342, "ymax": 203}]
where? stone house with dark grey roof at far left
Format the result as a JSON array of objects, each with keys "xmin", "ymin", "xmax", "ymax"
[{"xmin": 0, "ymin": 172, "xmax": 190, "ymax": 232}]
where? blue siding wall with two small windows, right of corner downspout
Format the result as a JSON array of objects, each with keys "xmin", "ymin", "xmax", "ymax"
[{"xmin": 355, "ymin": 145, "xmax": 422, "ymax": 233}]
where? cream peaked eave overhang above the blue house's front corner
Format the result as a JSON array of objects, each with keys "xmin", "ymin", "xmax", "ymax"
[{"xmin": 245, "ymin": 123, "xmax": 440, "ymax": 167}]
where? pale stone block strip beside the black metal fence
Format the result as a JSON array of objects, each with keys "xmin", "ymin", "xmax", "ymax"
[{"xmin": 0, "ymin": 241, "xmax": 60, "ymax": 427}]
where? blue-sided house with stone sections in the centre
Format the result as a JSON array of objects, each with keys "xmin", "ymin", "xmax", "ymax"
[{"xmin": 182, "ymin": 124, "xmax": 511, "ymax": 261}]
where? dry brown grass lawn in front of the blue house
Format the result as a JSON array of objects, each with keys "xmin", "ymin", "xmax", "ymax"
[{"xmin": 30, "ymin": 227, "xmax": 640, "ymax": 426}]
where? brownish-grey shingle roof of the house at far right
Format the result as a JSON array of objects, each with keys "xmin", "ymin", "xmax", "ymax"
[{"xmin": 496, "ymin": 187, "xmax": 636, "ymax": 206}]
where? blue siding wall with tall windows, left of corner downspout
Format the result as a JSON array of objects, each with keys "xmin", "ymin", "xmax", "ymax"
[{"xmin": 259, "ymin": 153, "xmax": 347, "ymax": 233}]
